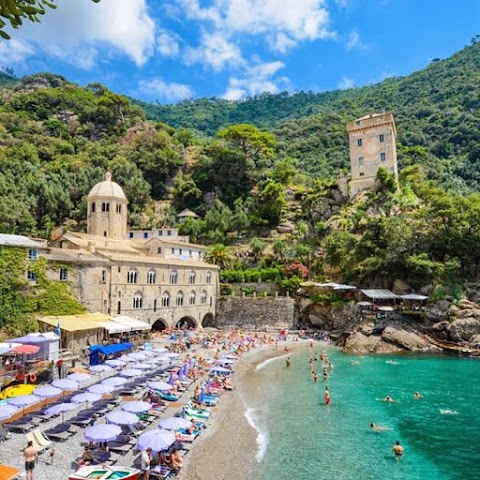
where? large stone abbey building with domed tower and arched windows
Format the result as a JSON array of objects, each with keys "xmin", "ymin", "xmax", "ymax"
[{"xmin": 0, "ymin": 173, "xmax": 219, "ymax": 330}]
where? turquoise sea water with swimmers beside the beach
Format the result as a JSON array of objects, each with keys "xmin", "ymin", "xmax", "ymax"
[{"xmin": 241, "ymin": 347, "xmax": 480, "ymax": 480}]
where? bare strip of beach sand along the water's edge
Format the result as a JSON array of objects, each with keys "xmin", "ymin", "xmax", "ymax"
[{"xmin": 178, "ymin": 340, "xmax": 309, "ymax": 480}]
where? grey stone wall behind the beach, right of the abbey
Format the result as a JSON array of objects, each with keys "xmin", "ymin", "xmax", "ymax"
[{"xmin": 216, "ymin": 297, "xmax": 295, "ymax": 328}]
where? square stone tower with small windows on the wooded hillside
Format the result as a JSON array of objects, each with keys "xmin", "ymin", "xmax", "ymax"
[{"xmin": 347, "ymin": 113, "xmax": 398, "ymax": 197}]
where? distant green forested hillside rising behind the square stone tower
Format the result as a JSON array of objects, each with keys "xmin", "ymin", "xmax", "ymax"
[{"xmin": 140, "ymin": 41, "xmax": 480, "ymax": 192}]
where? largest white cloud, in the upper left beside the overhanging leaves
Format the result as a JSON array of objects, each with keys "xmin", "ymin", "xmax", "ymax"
[{"xmin": 1, "ymin": 0, "xmax": 155, "ymax": 69}]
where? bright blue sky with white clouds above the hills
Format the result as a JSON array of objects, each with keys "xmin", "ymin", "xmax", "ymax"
[{"xmin": 0, "ymin": 0, "xmax": 480, "ymax": 103}]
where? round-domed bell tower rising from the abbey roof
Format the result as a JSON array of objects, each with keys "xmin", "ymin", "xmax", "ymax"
[{"xmin": 87, "ymin": 173, "xmax": 128, "ymax": 240}]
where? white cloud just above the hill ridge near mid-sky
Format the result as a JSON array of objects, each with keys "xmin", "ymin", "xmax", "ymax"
[{"xmin": 223, "ymin": 61, "xmax": 289, "ymax": 100}]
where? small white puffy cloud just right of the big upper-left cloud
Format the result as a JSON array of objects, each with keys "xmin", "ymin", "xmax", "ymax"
[{"xmin": 184, "ymin": 31, "xmax": 244, "ymax": 72}]
